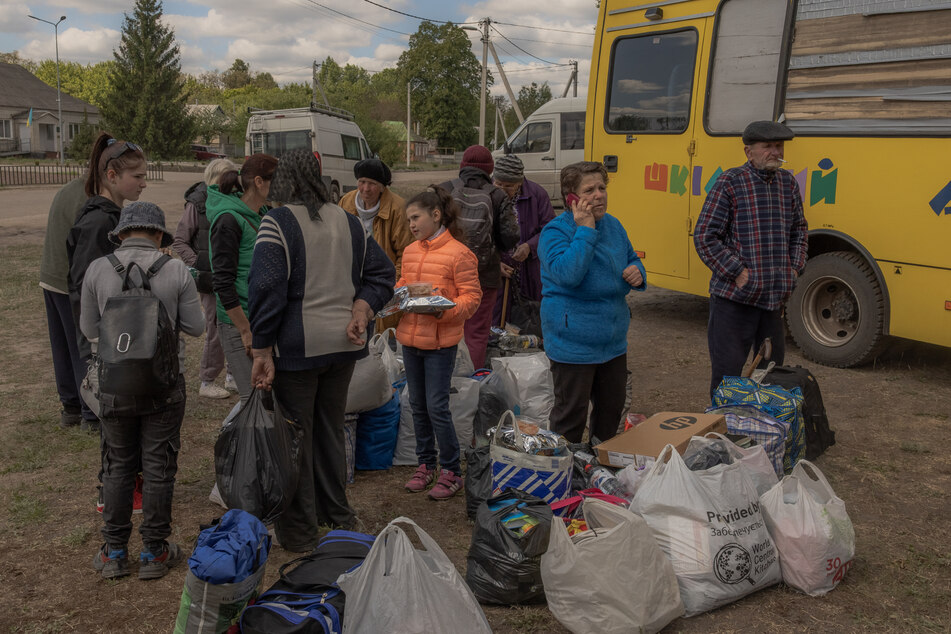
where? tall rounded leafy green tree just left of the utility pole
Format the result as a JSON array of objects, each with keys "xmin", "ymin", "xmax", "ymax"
[{"xmin": 396, "ymin": 22, "xmax": 491, "ymax": 148}]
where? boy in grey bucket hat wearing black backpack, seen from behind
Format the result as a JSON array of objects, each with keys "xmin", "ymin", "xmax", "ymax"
[{"xmin": 79, "ymin": 201, "xmax": 205, "ymax": 579}]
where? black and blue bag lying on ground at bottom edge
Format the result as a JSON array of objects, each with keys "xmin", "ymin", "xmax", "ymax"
[{"xmin": 241, "ymin": 530, "xmax": 374, "ymax": 634}]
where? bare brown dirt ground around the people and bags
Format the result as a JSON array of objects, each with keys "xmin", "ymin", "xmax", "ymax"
[{"xmin": 0, "ymin": 174, "xmax": 951, "ymax": 633}]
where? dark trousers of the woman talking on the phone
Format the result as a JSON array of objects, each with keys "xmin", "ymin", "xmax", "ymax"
[{"xmin": 549, "ymin": 353, "xmax": 627, "ymax": 442}]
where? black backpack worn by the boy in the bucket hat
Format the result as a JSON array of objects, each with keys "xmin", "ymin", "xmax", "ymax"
[{"xmin": 98, "ymin": 254, "xmax": 179, "ymax": 397}]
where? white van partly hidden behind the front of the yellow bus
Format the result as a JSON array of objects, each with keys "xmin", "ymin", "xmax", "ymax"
[{"xmin": 492, "ymin": 97, "xmax": 588, "ymax": 207}]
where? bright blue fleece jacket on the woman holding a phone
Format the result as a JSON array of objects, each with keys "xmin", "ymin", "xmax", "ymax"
[{"xmin": 538, "ymin": 211, "xmax": 647, "ymax": 364}]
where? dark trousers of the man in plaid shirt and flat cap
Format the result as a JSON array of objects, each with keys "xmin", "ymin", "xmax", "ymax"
[{"xmin": 707, "ymin": 295, "xmax": 786, "ymax": 396}]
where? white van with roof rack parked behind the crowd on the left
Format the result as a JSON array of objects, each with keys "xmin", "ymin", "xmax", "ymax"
[{"xmin": 244, "ymin": 105, "xmax": 373, "ymax": 203}]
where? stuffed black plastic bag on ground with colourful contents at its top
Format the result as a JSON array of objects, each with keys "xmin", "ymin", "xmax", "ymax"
[{"xmin": 466, "ymin": 489, "xmax": 552, "ymax": 605}]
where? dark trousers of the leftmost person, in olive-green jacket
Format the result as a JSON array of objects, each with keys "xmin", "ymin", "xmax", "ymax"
[{"xmin": 43, "ymin": 288, "xmax": 85, "ymax": 418}]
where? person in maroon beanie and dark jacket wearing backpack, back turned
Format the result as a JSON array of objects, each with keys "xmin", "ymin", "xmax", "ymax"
[{"xmin": 441, "ymin": 145, "xmax": 520, "ymax": 368}]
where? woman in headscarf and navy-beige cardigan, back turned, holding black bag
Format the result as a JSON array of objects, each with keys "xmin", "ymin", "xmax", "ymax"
[{"xmin": 248, "ymin": 150, "xmax": 396, "ymax": 552}]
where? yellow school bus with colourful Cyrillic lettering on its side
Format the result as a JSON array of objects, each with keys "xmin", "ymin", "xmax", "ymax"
[{"xmin": 585, "ymin": 0, "xmax": 951, "ymax": 367}]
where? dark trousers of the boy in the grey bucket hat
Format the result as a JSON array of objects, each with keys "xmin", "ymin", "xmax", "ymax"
[{"xmin": 100, "ymin": 375, "xmax": 185, "ymax": 549}]
